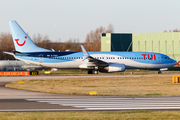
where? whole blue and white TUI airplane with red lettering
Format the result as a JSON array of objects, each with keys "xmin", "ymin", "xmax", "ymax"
[{"xmin": 4, "ymin": 20, "xmax": 177, "ymax": 74}]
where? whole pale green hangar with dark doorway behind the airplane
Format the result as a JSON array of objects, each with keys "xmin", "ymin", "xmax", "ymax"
[{"xmin": 101, "ymin": 32, "xmax": 180, "ymax": 61}]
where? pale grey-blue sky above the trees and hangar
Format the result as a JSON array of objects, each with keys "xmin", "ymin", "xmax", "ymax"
[{"xmin": 0, "ymin": 0, "xmax": 180, "ymax": 42}]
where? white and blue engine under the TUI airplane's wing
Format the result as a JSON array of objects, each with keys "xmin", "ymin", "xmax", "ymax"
[{"xmin": 99, "ymin": 63, "xmax": 125, "ymax": 72}]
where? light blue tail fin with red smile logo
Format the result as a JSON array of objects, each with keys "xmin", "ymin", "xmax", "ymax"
[{"xmin": 9, "ymin": 20, "xmax": 50, "ymax": 53}]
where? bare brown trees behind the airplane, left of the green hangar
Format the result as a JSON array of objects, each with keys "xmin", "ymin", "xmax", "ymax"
[{"xmin": 0, "ymin": 24, "xmax": 114, "ymax": 60}]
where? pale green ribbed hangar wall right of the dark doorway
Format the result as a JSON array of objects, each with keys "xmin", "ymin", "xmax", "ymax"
[{"xmin": 132, "ymin": 32, "xmax": 180, "ymax": 61}]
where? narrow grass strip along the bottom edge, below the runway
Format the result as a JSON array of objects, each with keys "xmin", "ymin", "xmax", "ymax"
[{"xmin": 0, "ymin": 110, "xmax": 180, "ymax": 120}]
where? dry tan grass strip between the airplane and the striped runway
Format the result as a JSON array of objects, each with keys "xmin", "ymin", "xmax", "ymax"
[{"xmin": 6, "ymin": 76, "xmax": 180, "ymax": 97}]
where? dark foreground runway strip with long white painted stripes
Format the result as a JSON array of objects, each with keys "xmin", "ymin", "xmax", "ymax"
[{"xmin": 0, "ymin": 97, "xmax": 180, "ymax": 112}]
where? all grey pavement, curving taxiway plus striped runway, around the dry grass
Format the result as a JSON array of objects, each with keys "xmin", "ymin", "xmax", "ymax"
[{"xmin": 0, "ymin": 75, "xmax": 180, "ymax": 112}]
